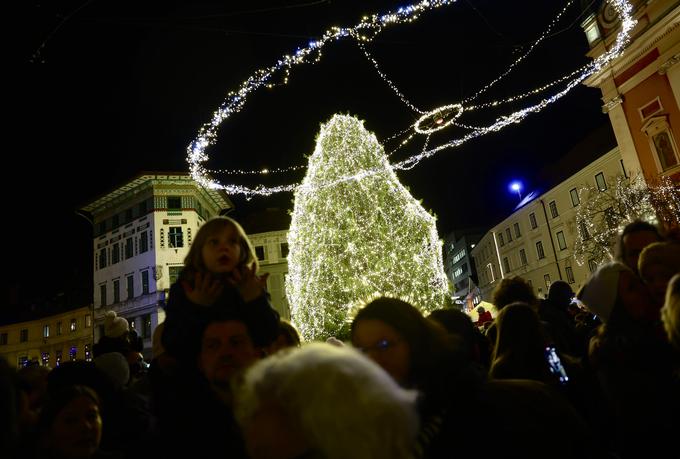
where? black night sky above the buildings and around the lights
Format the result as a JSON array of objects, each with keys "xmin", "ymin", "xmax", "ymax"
[{"xmin": 14, "ymin": 0, "xmax": 608, "ymax": 306}]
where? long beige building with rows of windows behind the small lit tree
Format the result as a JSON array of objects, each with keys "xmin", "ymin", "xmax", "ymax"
[{"xmin": 472, "ymin": 148, "xmax": 624, "ymax": 301}]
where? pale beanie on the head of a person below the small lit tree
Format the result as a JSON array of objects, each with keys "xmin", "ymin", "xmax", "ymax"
[{"xmin": 576, "ymin": 261, "xmax": 630, "ymax": 322}]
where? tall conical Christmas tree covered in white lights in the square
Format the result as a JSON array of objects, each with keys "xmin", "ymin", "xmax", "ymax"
[{"xmin": 286, "ymin": 115, "xmax": 447, "ymax": 340}]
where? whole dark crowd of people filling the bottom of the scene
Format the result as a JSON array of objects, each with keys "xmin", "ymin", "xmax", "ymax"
[{"xmin": 0, "ymin": 217, "xmax": 680, "ymax": 459}]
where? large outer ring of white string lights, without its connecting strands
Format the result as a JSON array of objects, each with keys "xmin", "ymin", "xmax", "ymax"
[{"xmin": 187, "ymin": 0, "xmax": 636, "ymax": 196}]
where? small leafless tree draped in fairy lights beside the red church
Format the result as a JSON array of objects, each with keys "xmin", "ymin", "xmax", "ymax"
[{"xmin": 574, "ymin": 175, "xmax": 680, "ymax": 264}]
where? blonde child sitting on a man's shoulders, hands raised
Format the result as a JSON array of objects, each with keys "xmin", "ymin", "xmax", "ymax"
[{"xmin": 161, "ymin": 217, "xmax": 279, "ymax": 365}]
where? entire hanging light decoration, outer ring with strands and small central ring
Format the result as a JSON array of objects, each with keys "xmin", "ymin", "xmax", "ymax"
[{"xmin": 187, "ymin": 0, "xmax": 636, "ymax": 196}]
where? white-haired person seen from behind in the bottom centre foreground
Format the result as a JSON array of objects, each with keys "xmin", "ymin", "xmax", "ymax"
[{"xmin": 234, "ymin": 343, "xmax": 418, "ymax": 459}]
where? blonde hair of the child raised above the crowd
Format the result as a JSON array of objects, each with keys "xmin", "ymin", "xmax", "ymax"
[{"xmin": 182, "ymin": 216, "xmax": 259, "ymax": 281}]
